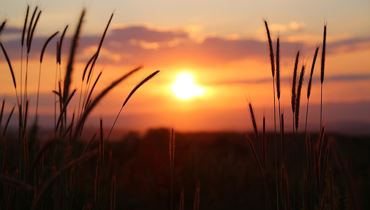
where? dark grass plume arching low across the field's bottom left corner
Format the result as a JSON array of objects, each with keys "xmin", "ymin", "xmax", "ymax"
[{"xmin": 31, "ymin": 150, "xmax": 99, "ymax": 210}]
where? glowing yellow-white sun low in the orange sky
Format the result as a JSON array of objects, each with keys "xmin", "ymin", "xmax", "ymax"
[{"xmin": 172, "ymin": 72, "xmax": 204, "ymax": 100}]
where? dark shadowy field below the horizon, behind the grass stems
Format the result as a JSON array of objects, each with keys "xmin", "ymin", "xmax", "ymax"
[{"xmin": 0, "ymin": 129, "xmax": 370, "ymax": 210}]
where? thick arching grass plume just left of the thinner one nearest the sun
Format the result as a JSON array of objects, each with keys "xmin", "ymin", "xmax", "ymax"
[{"xmin": 74, "ymin": 66, "xmax": 142, "ymax": 139}]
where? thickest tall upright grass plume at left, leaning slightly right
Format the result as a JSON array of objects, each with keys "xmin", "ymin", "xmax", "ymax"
[{"xmin": 64, "ymin": 9, "xmax": 85, "ymax": 109}]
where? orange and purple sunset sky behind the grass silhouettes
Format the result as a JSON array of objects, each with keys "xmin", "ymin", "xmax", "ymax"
[{"xmin": 0, "ymin": 0, "xmax": 370, "ymax": 132}]
